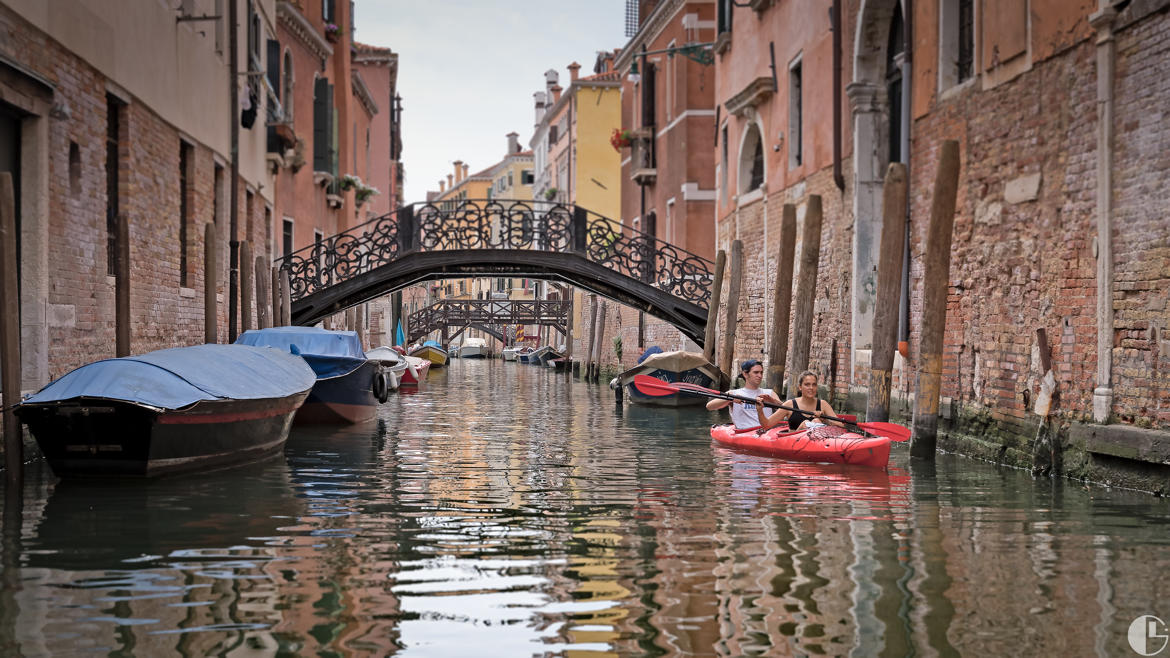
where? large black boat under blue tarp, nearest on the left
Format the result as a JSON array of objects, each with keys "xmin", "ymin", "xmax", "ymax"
[{"xmin": 15, "ymin": 344, "xmax": 316, "ymax": 478}]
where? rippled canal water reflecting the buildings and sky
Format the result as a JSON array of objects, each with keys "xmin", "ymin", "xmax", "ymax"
[{"xmin": 0, "ymin": 359, "xmax": 1170, "ymax": 656}]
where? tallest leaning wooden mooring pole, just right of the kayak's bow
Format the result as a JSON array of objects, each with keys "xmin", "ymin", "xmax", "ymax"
[{"xmin": 910, "ymin": 139, "xmax": 959, "ymax": 459}]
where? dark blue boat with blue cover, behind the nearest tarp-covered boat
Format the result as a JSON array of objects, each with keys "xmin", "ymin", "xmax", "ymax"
[{"xmin": 235, "ymin": 327, "xmax": 390, "ymax": 425}]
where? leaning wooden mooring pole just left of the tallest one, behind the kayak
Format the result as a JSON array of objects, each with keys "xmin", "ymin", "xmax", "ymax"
[{"xmin": 866, "ymin": 163, "xmax": 907, "ymax": 423}]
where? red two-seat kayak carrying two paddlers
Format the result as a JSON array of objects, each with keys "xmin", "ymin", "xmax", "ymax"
[{"xmin": 711, "ymin": 425, "xmax": 890, "ymax": 468}]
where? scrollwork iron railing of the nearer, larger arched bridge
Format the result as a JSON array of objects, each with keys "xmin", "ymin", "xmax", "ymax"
[{"xmin": 277, "ymin": 199, "xmax": 714, "ymax": 309}]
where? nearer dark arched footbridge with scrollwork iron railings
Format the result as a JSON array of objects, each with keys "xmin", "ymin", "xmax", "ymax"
[{"xmin": 277, "ymin": 199, "xmax": 714, "ymax": 345}]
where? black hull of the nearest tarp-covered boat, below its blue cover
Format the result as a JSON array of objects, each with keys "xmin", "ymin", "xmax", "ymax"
[{"xmin": 16, "ymin": 391, "xmax": 309, "ymax": 478}]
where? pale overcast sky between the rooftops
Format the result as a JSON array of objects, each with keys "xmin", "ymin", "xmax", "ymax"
[{"xmin": 355, "ymin": 0, "xmax": 627, "ymax": 203}]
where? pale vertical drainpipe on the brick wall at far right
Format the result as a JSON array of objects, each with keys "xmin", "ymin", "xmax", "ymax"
[{"xmin": 1089, "ymin": 0, "xmax": 1117, "ymax": 423}]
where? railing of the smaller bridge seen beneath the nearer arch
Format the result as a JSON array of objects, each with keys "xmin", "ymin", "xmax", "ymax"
[{"xmin": 406, "ymin": 300, "xmax": 572, "ymax": 341}]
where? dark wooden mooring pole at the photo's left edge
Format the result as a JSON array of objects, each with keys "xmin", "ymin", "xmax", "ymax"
[{"xmin": 0, "ymin": 171, "xmax": 25, "ymax": 484}]
